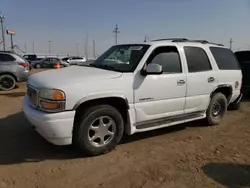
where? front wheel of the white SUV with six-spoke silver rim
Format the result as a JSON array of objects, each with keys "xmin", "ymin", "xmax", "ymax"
[{"xmin": 73, "ymin": 105, "xmax": 124, "ymax": 156}]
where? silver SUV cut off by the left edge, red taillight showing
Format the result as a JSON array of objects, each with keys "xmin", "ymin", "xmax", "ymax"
[{"xmin": 0, "ymin": 51, "xmax": 29, "ymax": 91}]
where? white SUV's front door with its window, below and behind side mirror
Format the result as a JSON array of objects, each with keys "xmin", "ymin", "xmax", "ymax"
[{"xmin": 134, "ymin": 46, "xmax": 187, "ymax": 123}]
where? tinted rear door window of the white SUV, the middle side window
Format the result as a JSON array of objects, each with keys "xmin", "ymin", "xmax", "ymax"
[{"xmin": 184, "ymin": 47, "xmax": 212, "ymax": 72}]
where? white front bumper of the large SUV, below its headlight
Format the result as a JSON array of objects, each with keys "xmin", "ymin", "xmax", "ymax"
[{"xmin": 23, "ymin": 96, "xmax": 75, "ymax": 145}]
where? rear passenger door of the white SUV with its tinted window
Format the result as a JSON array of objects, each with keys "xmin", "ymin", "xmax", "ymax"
[{"xmin": 184, "ymin": 46, "xmax": 217, "ymax": 113}]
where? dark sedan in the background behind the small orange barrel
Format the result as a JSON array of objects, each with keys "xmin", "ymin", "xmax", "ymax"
[{"xmin": 31, "ymin": 57, "xmax": 69, "ymax": 69}]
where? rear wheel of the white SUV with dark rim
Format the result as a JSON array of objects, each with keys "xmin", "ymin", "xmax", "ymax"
[{"xmin": 206, "ymin": 93, "xmax": 227, "ymax": 126}]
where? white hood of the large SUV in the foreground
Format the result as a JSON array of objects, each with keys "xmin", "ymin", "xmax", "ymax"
[{"xmin": 28, "ymin": 66, "xmax": 122, "ymax": 89}]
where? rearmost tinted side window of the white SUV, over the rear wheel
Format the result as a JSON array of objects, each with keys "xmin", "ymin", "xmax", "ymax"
[{"xmin": 210, "ymin": 47, "xmax": 240, "ymax": 70}]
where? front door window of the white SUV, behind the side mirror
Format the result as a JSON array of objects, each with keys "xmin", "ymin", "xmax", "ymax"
[{"xmin": 148, "ymin": 47, "xmax": 182, "ymax": 73}]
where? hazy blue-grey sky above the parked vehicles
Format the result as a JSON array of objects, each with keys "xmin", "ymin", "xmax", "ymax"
[{"xmin": 0, "ymin": 0, "xmax": 250, "ymax": 56}]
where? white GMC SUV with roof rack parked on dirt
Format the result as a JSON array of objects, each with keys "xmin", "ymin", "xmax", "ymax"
[{"xmin": 23, "ymin": 39, "xmax": 242, "ymax": 155}]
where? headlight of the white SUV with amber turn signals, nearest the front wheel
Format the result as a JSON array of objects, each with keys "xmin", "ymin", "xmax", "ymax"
[{"xmin": 39, "ymin": 89, "xmax": 66, "ymax": 112}]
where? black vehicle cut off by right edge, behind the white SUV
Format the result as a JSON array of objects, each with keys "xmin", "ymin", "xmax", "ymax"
[{"xmin": 235, "ymin": 51, "xmax": 250, "ymax": 94}]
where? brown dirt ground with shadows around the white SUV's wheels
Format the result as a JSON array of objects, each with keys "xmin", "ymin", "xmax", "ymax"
[{"xmin": 0, "ymin": 69, "xmax": 250, "ymax": 188}]
